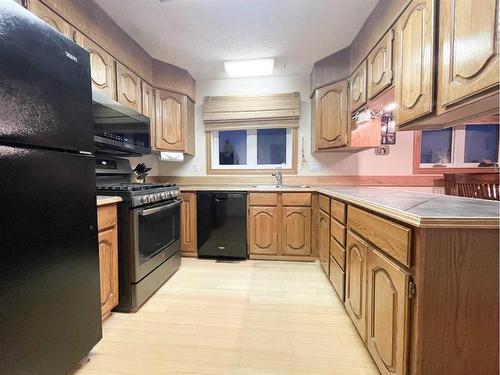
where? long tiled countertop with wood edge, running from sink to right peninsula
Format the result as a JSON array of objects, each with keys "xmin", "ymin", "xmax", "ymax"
[{"xmin": 180, "ymin": 185, "xmax": 500, "ymax": 228}]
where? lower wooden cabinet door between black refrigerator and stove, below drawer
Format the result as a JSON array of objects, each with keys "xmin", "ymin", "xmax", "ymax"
[{"xmin": 98, "ymin": 226, "xmax": 118, "ymax": 319}]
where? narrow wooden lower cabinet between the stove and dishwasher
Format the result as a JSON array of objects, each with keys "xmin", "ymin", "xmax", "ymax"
[{"xmin": 181, "ymin": 192, "xmax": 198, "ymax": 257}]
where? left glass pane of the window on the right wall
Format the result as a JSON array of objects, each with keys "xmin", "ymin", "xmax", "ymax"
[{"xmin": 420, "ymin": 128, "xmax": 453, "ymax": 164}]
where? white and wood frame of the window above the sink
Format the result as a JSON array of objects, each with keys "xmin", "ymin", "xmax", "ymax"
[{"xmin": 205, "ymin": 128, "xmax": 298, "ymax": 175}]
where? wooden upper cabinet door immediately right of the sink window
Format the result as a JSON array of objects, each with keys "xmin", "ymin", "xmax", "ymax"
[{"xmin": 312, "ymin": 81, "xmax": 349, "ymax": 151}]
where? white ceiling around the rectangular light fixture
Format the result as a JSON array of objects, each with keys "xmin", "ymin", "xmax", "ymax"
[{"xmin": 96, "ymin": 0, "xmax": 378, "ymax": 80}]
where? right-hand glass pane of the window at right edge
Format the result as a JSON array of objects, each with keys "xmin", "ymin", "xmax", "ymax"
[{"xmin": 464, "ymin": 124, "xmax": 498, "ymax": 163}]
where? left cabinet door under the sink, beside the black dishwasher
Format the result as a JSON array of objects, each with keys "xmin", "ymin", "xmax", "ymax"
[{"xmin": 248, "ymin": 207, "xmax": 279, "ymax": 255}]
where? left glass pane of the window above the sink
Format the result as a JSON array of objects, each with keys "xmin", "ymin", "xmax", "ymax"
[{"xmin": 219, "ymin": 130, "xmax": 247, "ymax": 165}]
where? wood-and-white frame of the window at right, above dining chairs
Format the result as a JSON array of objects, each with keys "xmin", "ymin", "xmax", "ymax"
[{"xmin": 413, "ymin": 123, "xmax": 500, "ymax": 174}]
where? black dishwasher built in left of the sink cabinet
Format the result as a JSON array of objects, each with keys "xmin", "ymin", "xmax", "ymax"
[{"xmin": 197, "ymin": 191, "xmax": 247, "ymax": 259}]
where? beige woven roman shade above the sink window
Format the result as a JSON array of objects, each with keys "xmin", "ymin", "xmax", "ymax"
[{"xmin": 203, "ymin": 92, "xmax": 300, "ymax": 132}]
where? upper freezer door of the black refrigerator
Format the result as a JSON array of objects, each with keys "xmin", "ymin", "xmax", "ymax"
[{"xmin": 0, "ymin": 1, "xmax": 94, "ymax": 153}]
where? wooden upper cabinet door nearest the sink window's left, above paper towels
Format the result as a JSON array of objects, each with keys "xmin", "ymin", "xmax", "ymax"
[{"xmin": 156, "ymin": 90, "xmax": 187, "ymax": 151}]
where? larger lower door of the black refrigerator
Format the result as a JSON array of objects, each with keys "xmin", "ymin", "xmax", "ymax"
[{"xmin": 0, "ymin": 146, "xmax": 102, "ymax": 375}]
